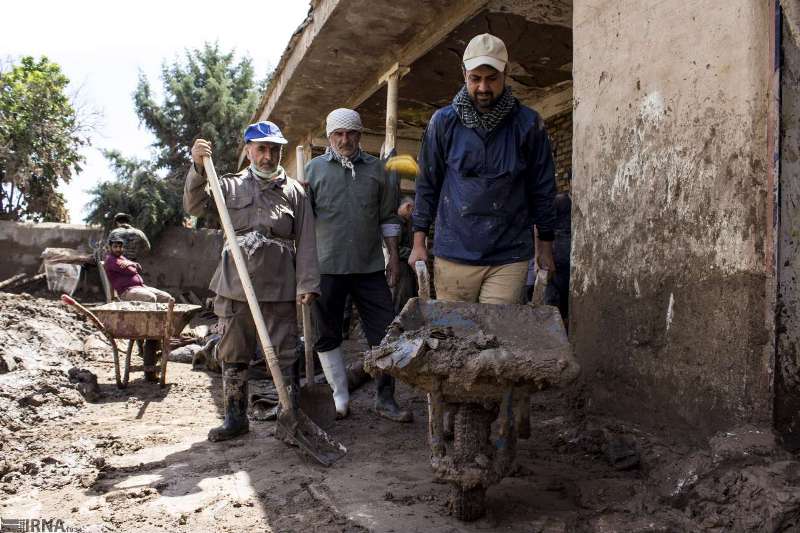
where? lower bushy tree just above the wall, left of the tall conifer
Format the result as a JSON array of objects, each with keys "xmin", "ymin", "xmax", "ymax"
[{"xmin": 86, "ymin": 150, "xmax": 183, "ymax": 240}]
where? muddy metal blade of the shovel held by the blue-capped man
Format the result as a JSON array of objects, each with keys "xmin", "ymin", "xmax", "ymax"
[{"xmin": 275, "ymin": 409, "xmax": 347, "ymax": 466}]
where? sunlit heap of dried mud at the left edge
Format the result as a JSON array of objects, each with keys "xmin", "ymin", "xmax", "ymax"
[{"xmin": 0, "ymin": 292, "xmax": 102, "ymax": 494}]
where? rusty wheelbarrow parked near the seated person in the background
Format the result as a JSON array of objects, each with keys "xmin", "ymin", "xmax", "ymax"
[{"xmin": 61, "ymin": 294, "xmax": 202, "ymax": 389}]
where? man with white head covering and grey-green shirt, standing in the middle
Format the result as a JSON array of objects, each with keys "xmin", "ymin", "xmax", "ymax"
[{"xmin": 306, "ymin": 109, "xmax": 412, "ymax": 422}]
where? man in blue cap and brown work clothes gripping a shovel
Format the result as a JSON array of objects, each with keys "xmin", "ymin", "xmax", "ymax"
[{"xmin": 183, "ymin": 121, "xmax": 320, "ymax": 441}]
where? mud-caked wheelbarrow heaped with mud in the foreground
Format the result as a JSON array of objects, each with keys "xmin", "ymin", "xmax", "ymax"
[{"xmin": 364, "ymin": 262, "xmax": 580, "ymax": 521}]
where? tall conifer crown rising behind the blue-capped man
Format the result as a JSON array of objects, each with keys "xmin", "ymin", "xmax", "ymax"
[{"xmin": 133, "ymin": 43, "xmax": 263, "ymax": 179}]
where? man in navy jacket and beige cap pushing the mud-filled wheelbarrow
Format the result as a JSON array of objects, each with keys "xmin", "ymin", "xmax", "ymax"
[{"xmin": 409, "ymin": 33, "xmax": 555, "ymax": 304}]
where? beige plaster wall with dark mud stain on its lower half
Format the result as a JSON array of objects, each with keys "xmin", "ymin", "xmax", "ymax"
[{"xmin": 570, "ymin": 0, "xmax": 774, "ymax": 437}]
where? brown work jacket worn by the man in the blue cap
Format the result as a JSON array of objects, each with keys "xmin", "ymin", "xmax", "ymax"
[{"xmin": 183, "ymin": 165, "xmax": 320, "ymax": 302}]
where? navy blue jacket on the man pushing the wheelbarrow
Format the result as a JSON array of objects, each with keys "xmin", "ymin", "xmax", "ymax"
[{"xmin": 413, "ymin": 104, "xmax": 555, "ymax": 265}]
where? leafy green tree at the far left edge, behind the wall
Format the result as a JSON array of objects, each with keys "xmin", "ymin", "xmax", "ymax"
[{"xmin": 0, "ymin": 56, "xmax": 89, "ymax": 222}]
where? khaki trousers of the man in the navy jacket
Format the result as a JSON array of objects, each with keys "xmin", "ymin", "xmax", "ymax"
[{"xmin": 433, "ymin": 257, "xmax": 528, "ymax": 304}]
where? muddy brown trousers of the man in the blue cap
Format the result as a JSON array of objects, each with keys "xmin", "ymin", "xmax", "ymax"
[{"xmin": 214, "ymin": 296, "xmax": 297, "ymax": 379}]
